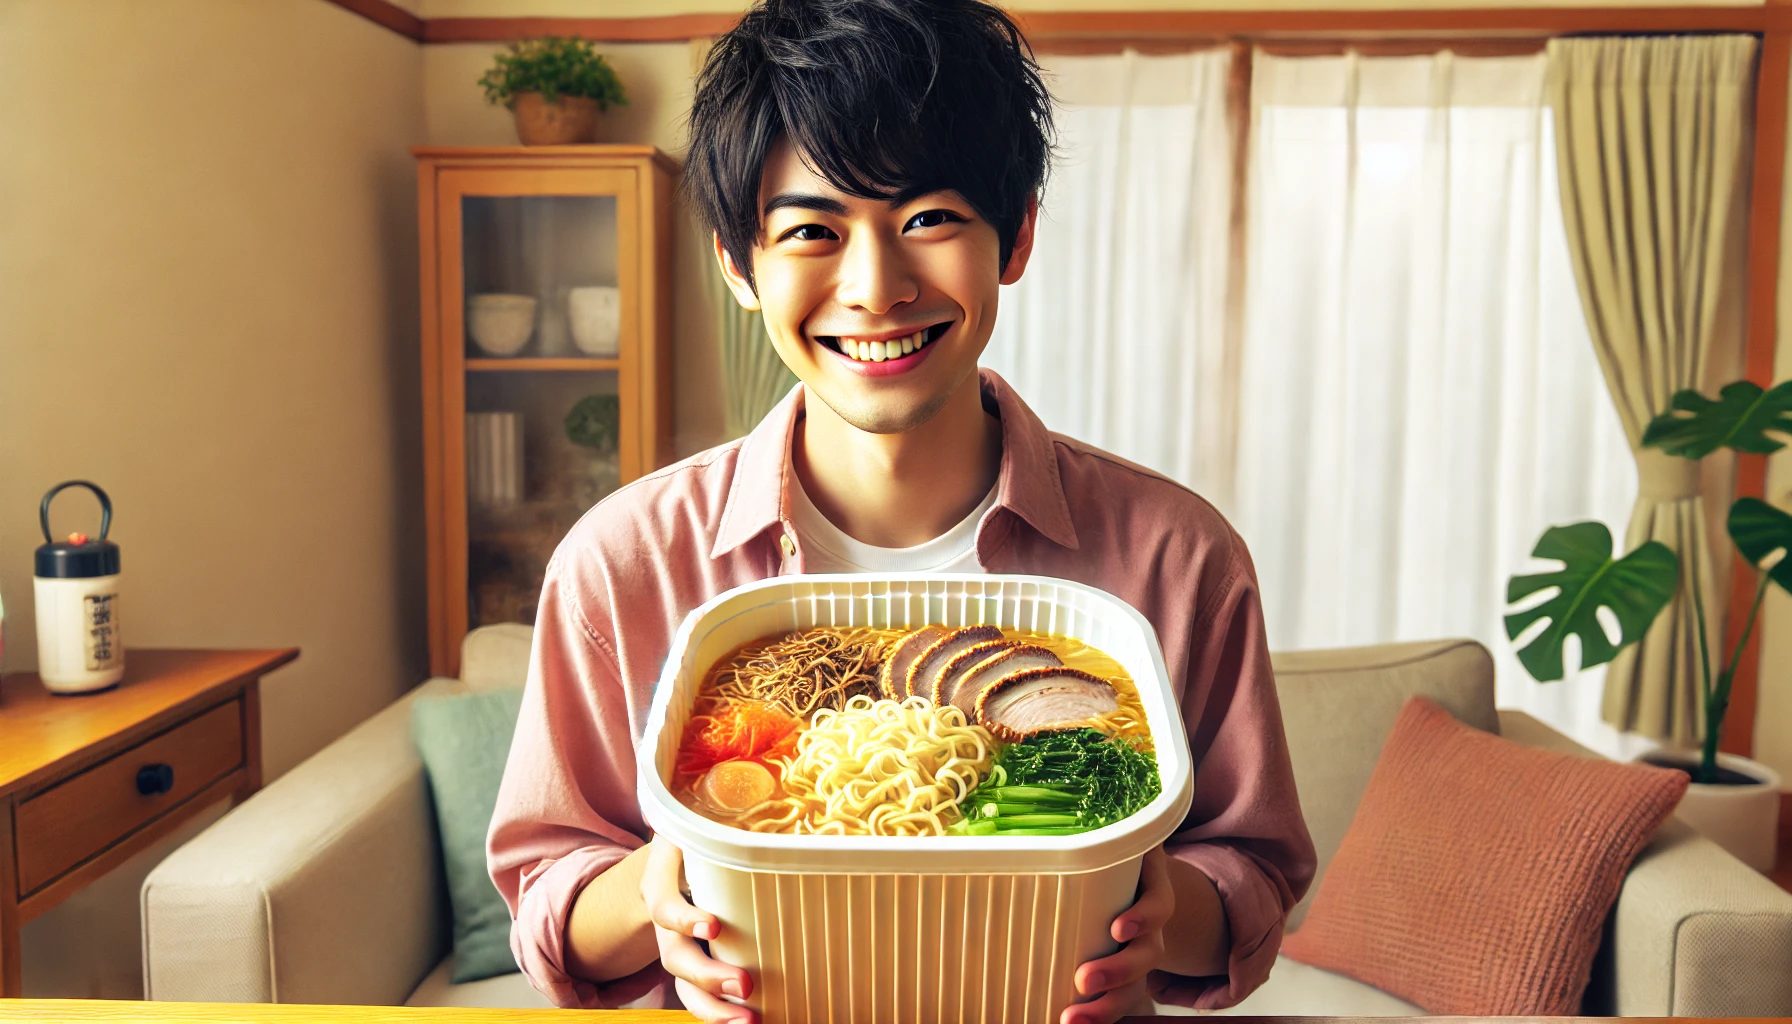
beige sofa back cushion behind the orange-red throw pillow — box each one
[1271,640,1500,931]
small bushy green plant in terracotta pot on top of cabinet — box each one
[478,36,629,145]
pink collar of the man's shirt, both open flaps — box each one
[710,369,1077,558]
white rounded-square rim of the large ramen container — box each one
[636,572,1193,875]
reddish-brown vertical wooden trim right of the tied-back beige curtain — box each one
[1720,26,1792,757]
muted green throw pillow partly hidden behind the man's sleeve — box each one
[410,689,523,985]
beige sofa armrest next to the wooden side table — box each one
[142,680,461,1004]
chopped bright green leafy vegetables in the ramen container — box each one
[950,728,1163,836]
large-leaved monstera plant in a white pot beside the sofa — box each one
[1505,380,1792,872]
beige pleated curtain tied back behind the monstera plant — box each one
[1546,36,1756,744]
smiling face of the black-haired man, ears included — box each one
[717,142,1034,434]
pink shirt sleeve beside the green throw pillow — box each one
[486,560,658,1008]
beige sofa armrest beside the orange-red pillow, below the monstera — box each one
[1500,712,1792,1017]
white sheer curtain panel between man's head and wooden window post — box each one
[984,50,1233,481]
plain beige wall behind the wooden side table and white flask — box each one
[0,0,426,995]
